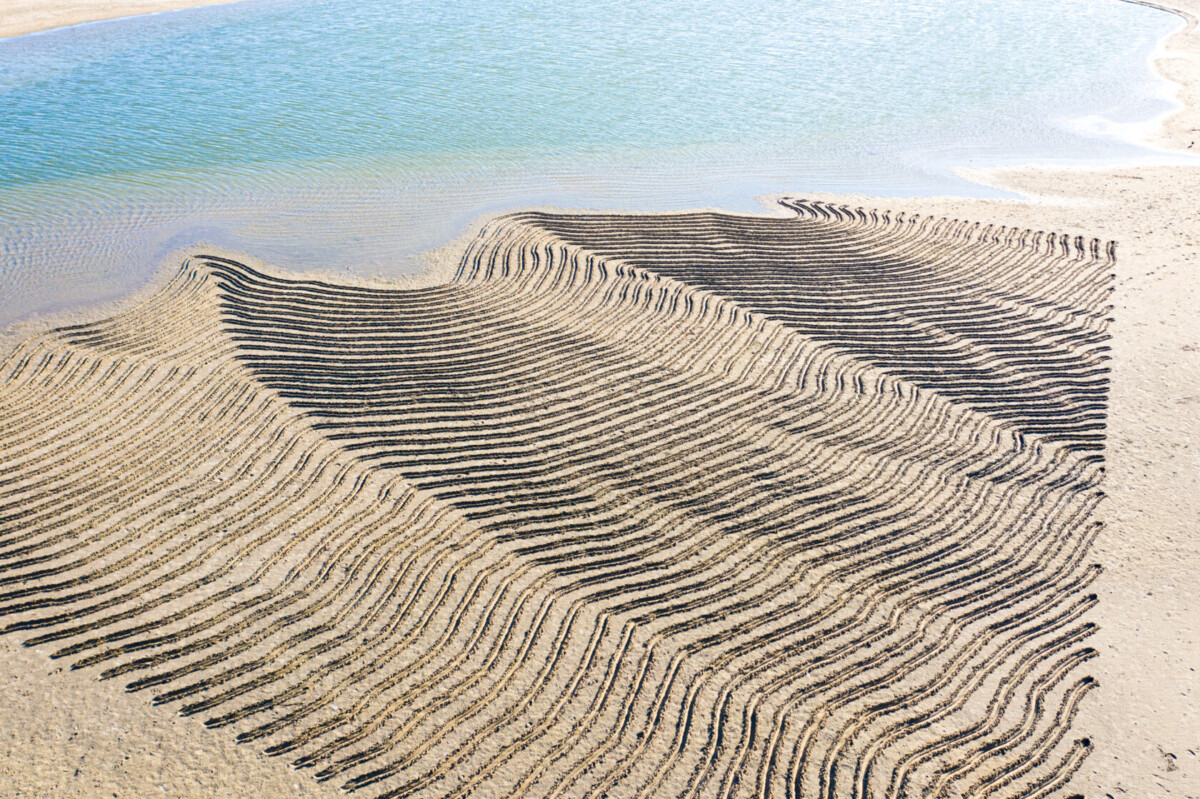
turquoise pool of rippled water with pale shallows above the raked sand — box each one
[0,0,1178,324]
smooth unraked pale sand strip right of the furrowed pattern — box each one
[787,161,1200,799]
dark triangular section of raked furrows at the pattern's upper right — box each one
[522,205,1110,450]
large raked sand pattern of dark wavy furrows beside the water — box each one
[0,200,1112,797]
